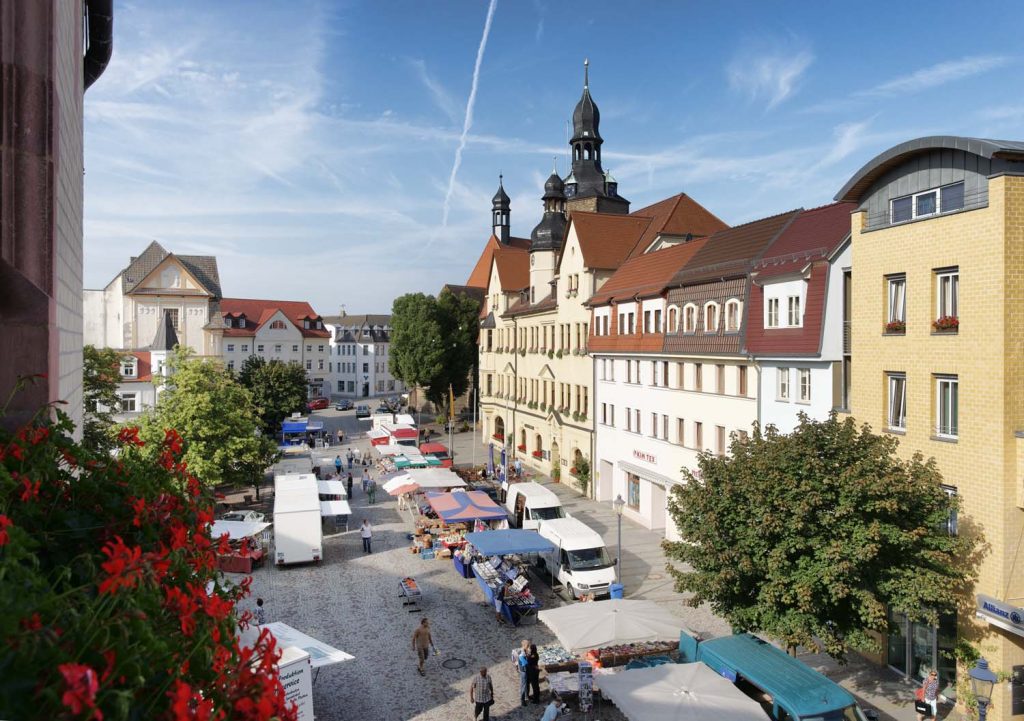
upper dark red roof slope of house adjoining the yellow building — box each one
[753,203,857,279]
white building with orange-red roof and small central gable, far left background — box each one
[220,298,331,397]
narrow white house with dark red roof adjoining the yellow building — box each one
[746,203,855,433]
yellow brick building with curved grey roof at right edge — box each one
[836,136,1024,720]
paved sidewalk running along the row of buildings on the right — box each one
[444,433,925,721]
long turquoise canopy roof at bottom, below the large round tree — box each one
[679,633,876,721]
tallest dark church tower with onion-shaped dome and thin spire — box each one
[565,60,630,215]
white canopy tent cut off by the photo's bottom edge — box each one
[583,663,766,721]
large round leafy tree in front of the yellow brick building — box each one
[665,414,975,661]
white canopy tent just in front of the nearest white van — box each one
[538,598,688,653]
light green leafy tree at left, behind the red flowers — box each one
[139,350,276,485]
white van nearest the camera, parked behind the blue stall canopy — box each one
[538,518,615,598]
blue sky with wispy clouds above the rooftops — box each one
[85,0,1024,314]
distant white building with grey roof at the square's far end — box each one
[324,311,407,398]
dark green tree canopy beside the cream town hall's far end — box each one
[388,291,479,407]
